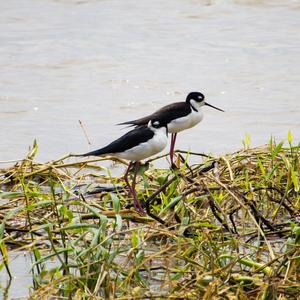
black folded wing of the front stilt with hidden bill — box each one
[82,126,154,156]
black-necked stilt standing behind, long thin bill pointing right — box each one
[118,92,224,165]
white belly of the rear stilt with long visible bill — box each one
[168,109,203,133]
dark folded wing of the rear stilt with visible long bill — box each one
[118,102,191,126]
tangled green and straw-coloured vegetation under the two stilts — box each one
[0,134,300,299]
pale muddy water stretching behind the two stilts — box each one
[0,0,300,298]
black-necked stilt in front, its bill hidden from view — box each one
[80,119,168,213]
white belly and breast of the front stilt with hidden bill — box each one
[115,127,168,161]
